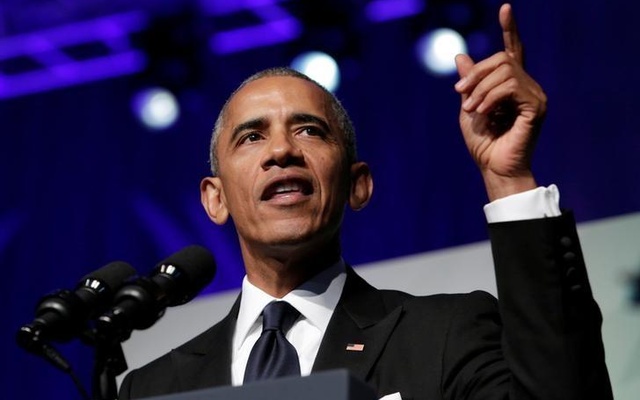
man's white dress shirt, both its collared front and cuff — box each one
[231,185,561,386]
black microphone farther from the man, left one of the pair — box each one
[16,261,136,354]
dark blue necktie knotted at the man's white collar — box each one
[244,301,300,383]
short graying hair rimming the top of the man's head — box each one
[209,67,358,176]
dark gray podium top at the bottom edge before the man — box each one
[139,369,377,400]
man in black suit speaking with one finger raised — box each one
[121,5,612,399]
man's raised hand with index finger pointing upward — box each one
[455,4,547,201]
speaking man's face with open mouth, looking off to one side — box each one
[212,77,350,252]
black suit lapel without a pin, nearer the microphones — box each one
[171,297,240,390]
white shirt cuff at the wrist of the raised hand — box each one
[484,185,561,224]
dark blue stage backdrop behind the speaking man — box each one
[0,0,640,400]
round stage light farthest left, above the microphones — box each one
[132,87,180,130]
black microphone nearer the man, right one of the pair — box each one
[97,245,216,340]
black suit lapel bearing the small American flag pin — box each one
[313,268,402,380]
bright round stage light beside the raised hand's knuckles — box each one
[416,28,467,75]
